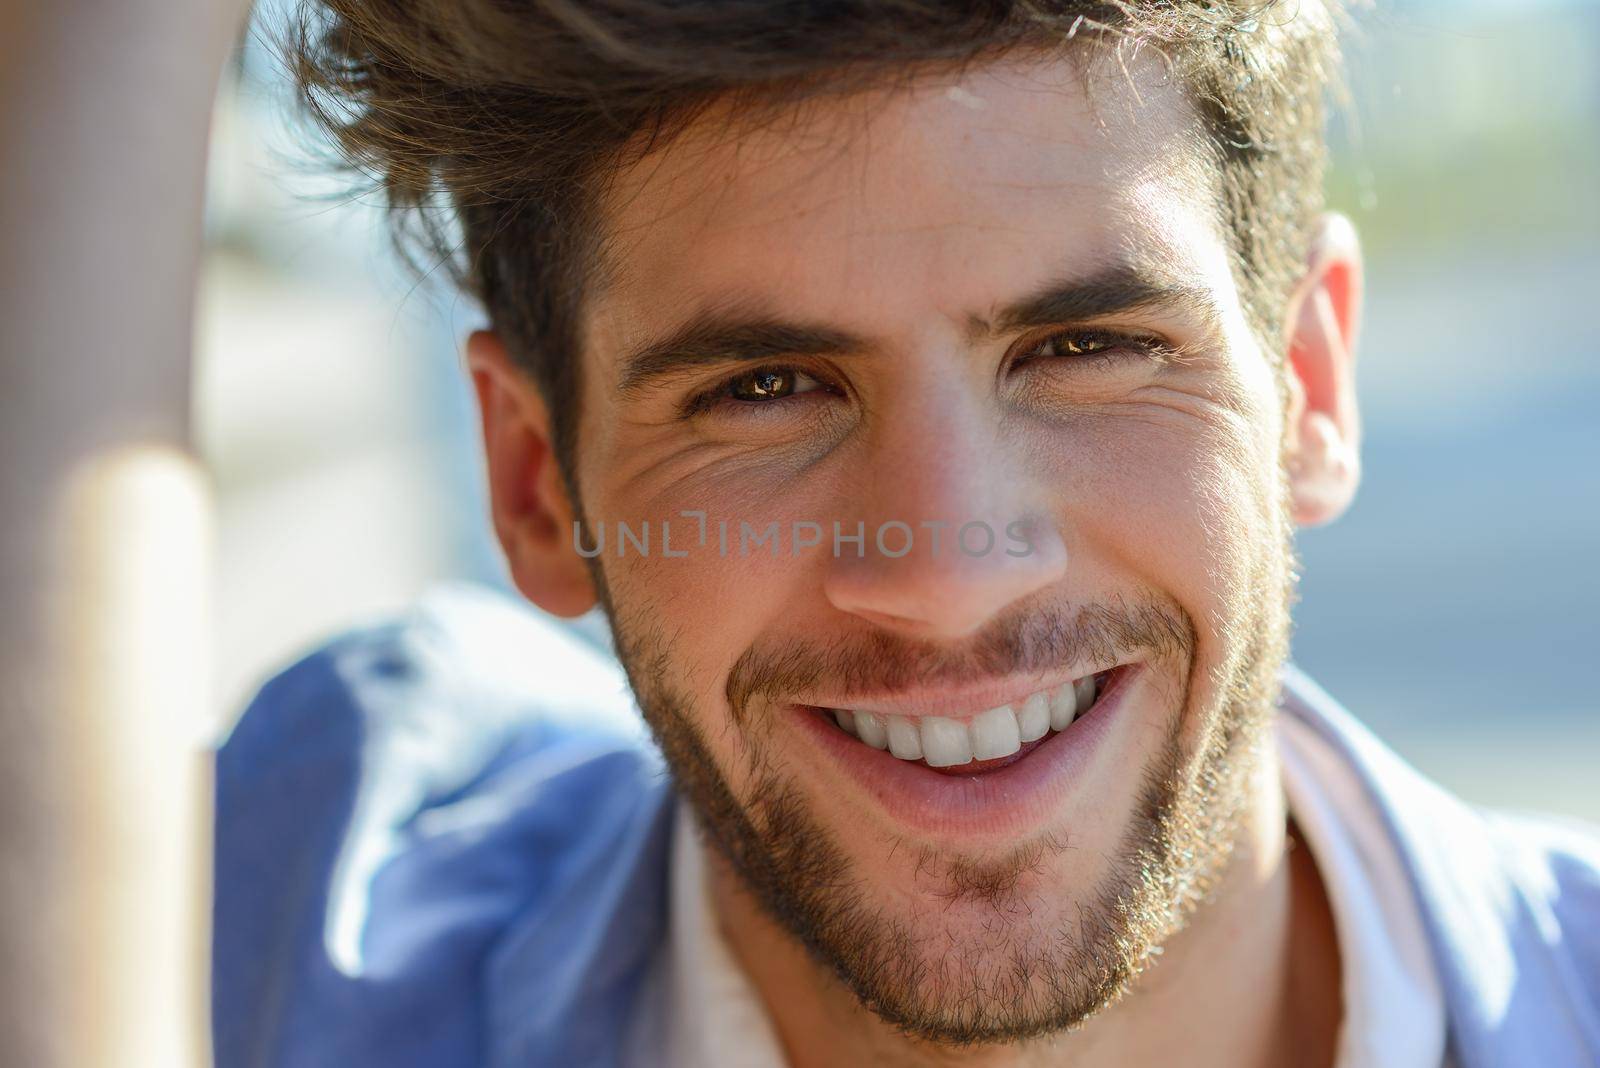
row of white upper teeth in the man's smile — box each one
[834,675,1094,767]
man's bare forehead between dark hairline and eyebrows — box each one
[584,53,1232,365]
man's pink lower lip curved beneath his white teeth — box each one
[790,665,1139,838]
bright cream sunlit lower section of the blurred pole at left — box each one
[56,444,213,1068]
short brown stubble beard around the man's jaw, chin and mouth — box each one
[594,511,1294,1047]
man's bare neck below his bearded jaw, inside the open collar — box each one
[702,745,1339,1068]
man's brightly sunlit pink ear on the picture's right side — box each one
[1285,214,1362,526]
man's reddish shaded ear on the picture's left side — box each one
[467,331,595,616]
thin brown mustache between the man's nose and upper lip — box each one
[725,595,1198,726]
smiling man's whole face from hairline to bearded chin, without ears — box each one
[576,49,1290,1039]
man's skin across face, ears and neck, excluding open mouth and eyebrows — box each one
[469,47,1360,1065]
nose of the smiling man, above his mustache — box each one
[824,383,1067,640]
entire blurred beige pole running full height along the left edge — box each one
[0,0,246,1068]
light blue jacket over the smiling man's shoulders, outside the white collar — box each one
[213,587,1600,1068]
